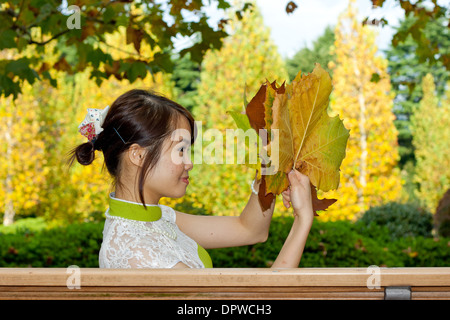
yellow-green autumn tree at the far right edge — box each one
[411,74,450,212]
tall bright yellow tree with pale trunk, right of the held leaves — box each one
[322,1,401,220]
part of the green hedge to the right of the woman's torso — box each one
[210,218,450,267]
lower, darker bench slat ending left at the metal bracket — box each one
[0,286,384,300]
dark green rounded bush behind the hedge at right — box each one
[356,202,433,241]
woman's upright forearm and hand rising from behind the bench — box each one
[272,170,314,268]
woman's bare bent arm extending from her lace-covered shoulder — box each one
[175,172,275,249]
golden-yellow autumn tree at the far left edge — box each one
[0,70,48,226]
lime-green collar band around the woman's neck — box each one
[109,192,162,221]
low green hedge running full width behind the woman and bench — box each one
[0,217,450,268]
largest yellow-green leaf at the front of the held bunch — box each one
[266,64,349,194]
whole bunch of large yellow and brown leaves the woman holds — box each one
[230,64,349,214]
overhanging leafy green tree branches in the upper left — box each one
[0,0,230,98]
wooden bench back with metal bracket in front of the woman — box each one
[0,267,450,300]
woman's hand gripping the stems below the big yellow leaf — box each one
[281,169,314,224]
